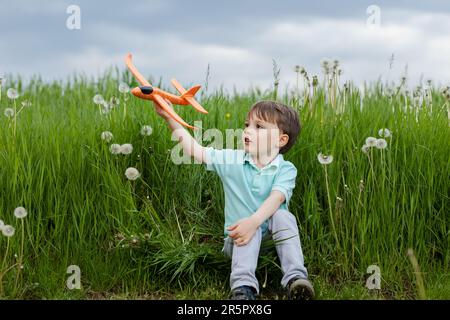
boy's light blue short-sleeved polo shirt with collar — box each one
[206,147,297,237]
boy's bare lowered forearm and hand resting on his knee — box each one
[227,190,285,246]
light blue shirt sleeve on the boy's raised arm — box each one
[205,147,242,177]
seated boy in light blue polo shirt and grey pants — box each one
[155,101,314,300]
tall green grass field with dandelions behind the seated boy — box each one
[0,63,450,299]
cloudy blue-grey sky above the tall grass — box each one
[0,0,450,91]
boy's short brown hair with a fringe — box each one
[247,101,301,153]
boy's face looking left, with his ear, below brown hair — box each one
[242,117,289,156]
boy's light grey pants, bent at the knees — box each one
[222,209,308,294]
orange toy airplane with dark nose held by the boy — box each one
[125,53,208,129]
